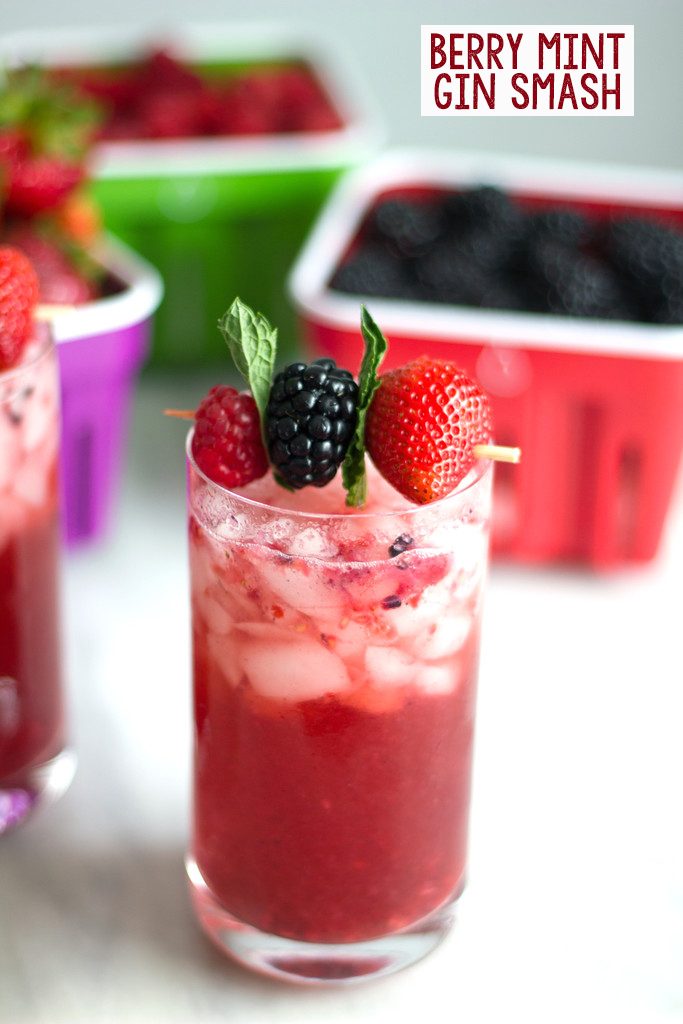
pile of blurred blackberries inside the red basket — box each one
[330,185,683,324]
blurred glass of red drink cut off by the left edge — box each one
[0,331,74,833]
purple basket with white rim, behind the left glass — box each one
[52,238,163,545]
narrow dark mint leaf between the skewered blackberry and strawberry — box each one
[342,306,388,508]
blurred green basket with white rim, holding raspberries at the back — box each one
[0,24,380,367]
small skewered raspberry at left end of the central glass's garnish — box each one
[193,385,268,487]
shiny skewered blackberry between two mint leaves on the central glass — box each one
[265,358,358,489]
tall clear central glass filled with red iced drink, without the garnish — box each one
[187,445,492,983]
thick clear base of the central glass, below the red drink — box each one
[185,857,456,986]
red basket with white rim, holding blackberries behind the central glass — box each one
[290,154,683,569]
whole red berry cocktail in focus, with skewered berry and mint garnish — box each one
[181,306,507,983]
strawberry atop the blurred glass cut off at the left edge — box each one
[0,246,38,371]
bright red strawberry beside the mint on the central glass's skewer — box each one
[366,356,492,505]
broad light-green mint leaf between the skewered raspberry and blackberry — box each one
[218,299,278,451]
